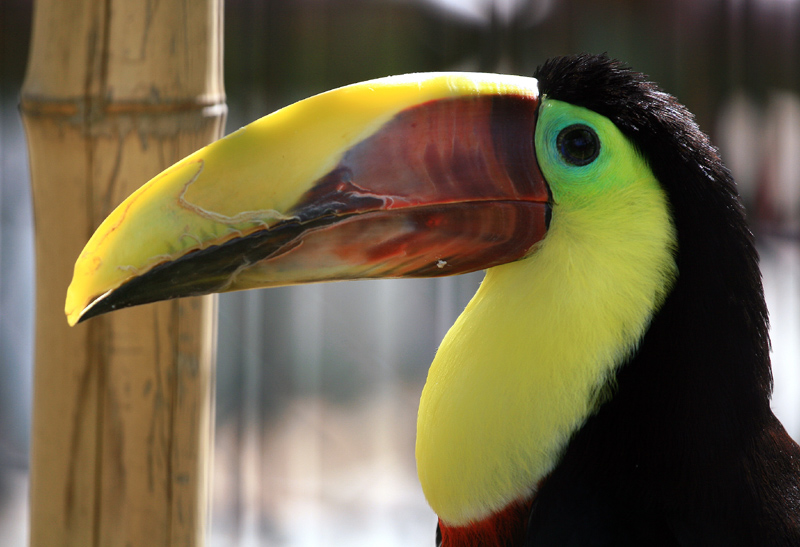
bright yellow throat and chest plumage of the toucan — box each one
[416,148,676,526]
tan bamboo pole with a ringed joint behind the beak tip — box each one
[21,0,226,547]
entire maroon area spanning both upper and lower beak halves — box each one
[281,96,548,277]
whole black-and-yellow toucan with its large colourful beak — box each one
[66,54,800,547]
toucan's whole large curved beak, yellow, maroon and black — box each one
[66,73,549,325]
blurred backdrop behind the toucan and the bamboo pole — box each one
[0,0,800,547]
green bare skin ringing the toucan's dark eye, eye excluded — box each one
[535,97,657,208]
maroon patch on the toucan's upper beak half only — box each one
[294,95,548,222]
